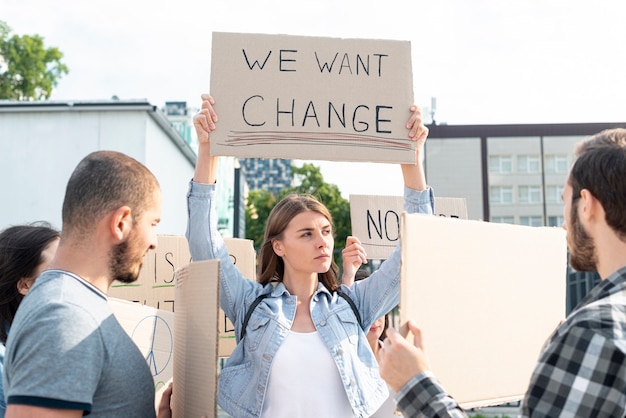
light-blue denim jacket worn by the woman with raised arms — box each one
[186,181,434,418]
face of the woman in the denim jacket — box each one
[272,211,335,276]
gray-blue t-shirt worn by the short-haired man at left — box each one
[4,270,156,417]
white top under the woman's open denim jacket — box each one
[261,331,354,418]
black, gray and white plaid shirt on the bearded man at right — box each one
[396,267,626,418]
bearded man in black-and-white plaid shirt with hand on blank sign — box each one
[380,129,626,417]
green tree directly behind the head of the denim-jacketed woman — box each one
[246,163,351,263]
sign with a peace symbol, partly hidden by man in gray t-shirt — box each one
[109,298,174,392]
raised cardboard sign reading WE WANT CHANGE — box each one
[211,32,415,163]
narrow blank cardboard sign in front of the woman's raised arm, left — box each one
[172,260,220,418]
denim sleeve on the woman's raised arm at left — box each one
[185,181,261,324]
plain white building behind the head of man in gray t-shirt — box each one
[0,100,196,235]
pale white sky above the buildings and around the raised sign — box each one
[0,0,626,197]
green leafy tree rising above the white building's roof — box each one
[0,21,69,100]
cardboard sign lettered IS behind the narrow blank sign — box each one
[108,235,256,357]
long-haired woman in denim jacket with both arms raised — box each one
[186,95,434,418]
